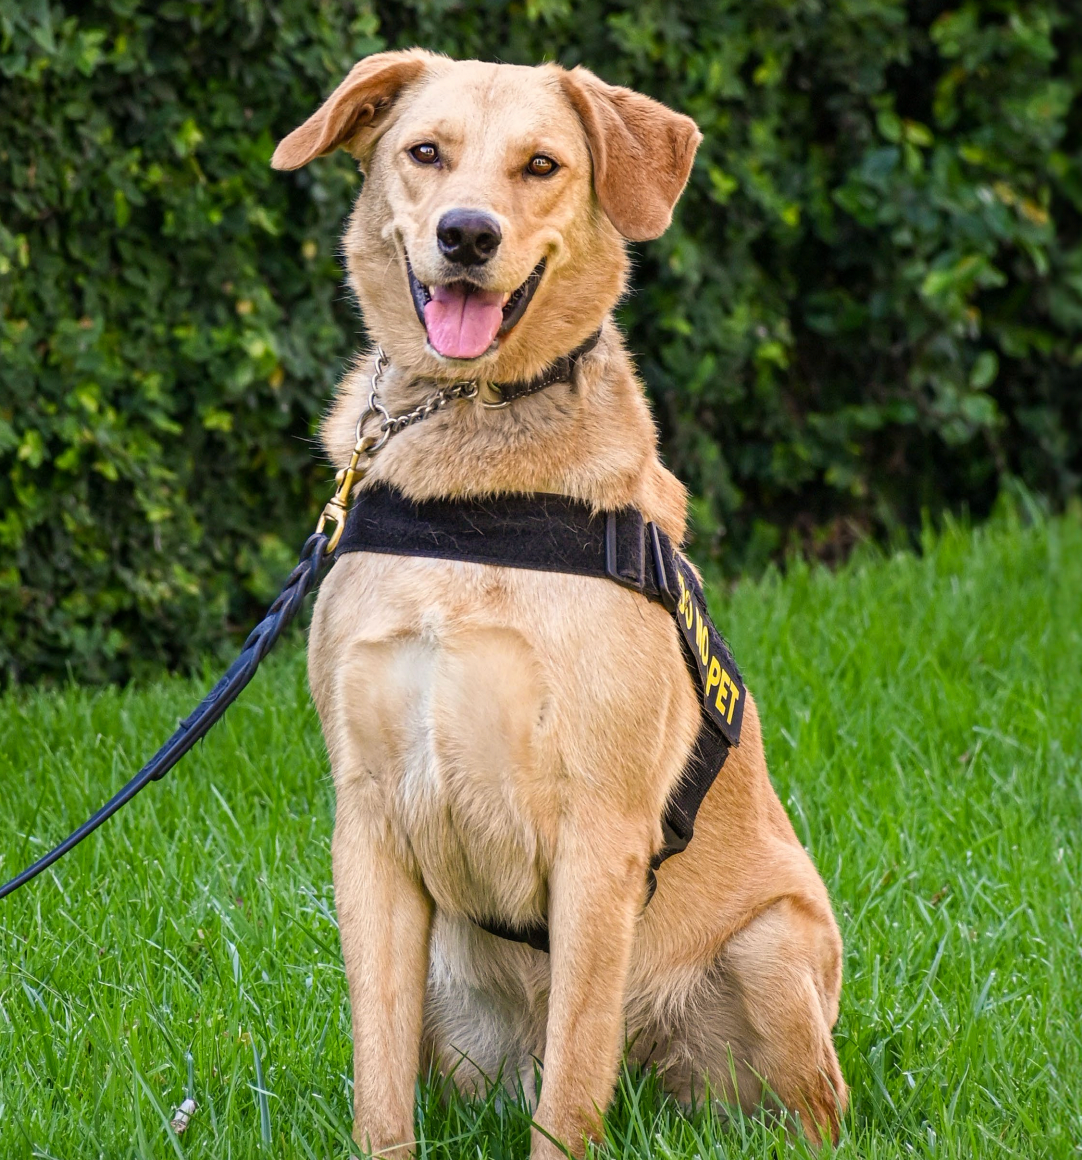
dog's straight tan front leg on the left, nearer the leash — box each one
[332,788,433,1158]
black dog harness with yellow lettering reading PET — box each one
[337,485,746,951]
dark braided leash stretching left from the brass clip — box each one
[0,531,331,899]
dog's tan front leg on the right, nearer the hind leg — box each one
[531,812,648,1160]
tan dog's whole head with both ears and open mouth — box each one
[273,50,700,379]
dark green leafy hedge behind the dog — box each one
[0,0,1082,680]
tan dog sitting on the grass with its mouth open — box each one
[273,50,847,1160]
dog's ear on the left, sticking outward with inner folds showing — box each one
[270,49,436,169]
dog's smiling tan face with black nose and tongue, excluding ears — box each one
[359,63,603,361]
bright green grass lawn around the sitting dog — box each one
[0,514,1082,1160]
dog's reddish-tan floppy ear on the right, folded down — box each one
[560,66,703,241]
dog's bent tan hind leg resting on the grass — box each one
[642,898,847,1144]
